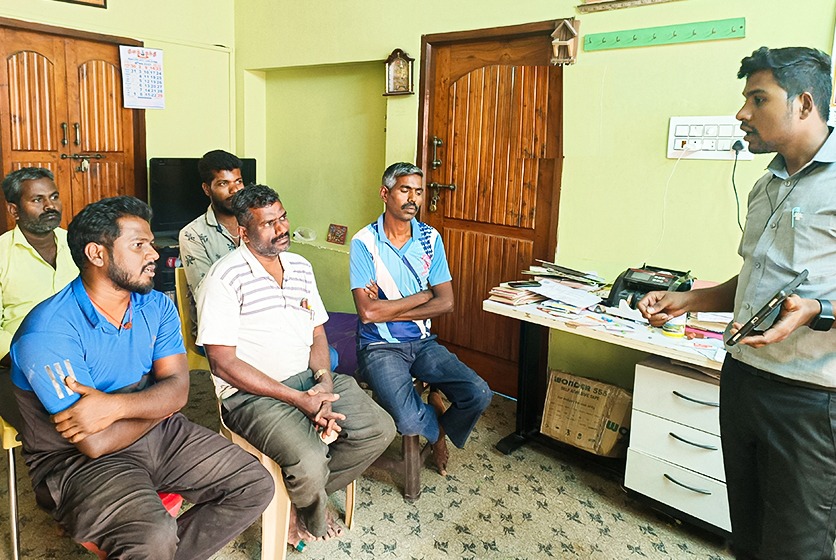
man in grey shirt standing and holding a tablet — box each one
[639,47,836,560]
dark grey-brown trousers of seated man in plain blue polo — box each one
[46,413,273,560]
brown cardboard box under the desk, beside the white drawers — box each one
[540,370,633,457]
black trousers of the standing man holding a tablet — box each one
[720,357,836,560]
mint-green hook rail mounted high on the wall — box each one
[583,18,746,51]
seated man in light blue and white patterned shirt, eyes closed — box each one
[350,163,493,475]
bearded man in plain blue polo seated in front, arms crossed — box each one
[11,196,273,560]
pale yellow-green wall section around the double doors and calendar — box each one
[0,0,235,164]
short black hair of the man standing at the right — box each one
[737,47,833,122]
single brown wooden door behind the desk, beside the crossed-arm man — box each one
[422,25,562,396]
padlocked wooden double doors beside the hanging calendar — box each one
[0,18,147,232]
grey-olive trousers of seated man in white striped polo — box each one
[223,369,395,537]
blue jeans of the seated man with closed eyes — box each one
[357,336,493,448]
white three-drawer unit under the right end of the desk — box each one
[624,356,731,531]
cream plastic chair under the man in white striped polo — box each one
[218,402,357,560]
